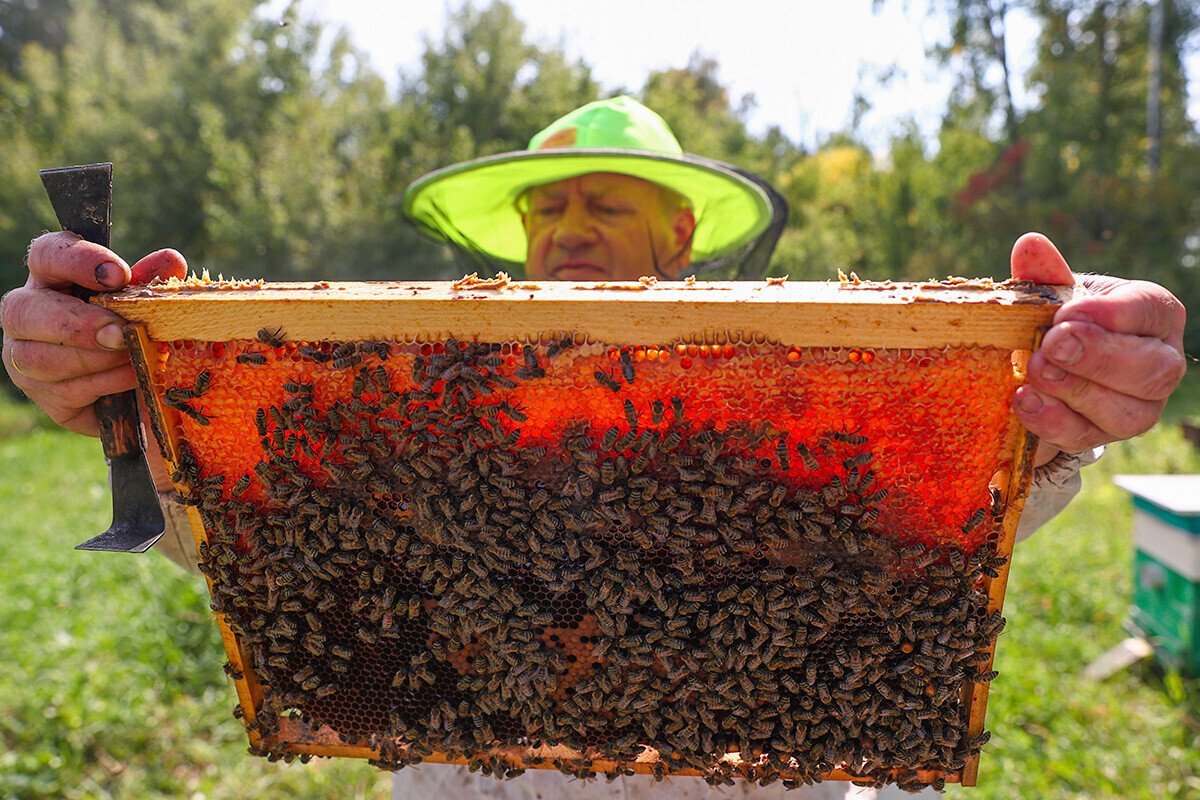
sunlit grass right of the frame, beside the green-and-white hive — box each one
[947,426,1200,800]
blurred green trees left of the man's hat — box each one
[0,0,463,291]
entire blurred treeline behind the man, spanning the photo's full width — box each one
[0,0,1200,353]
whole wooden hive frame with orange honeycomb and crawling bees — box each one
[102,279,1069,788]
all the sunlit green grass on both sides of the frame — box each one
[0,395,1200,800]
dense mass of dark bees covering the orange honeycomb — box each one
[168,331,1003,789]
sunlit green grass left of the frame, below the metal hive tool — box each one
[0,407,390,800]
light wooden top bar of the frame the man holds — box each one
[94,281,1074,349]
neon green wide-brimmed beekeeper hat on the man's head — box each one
[403,96,772,261]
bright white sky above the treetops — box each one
[266,0,1200,149]
